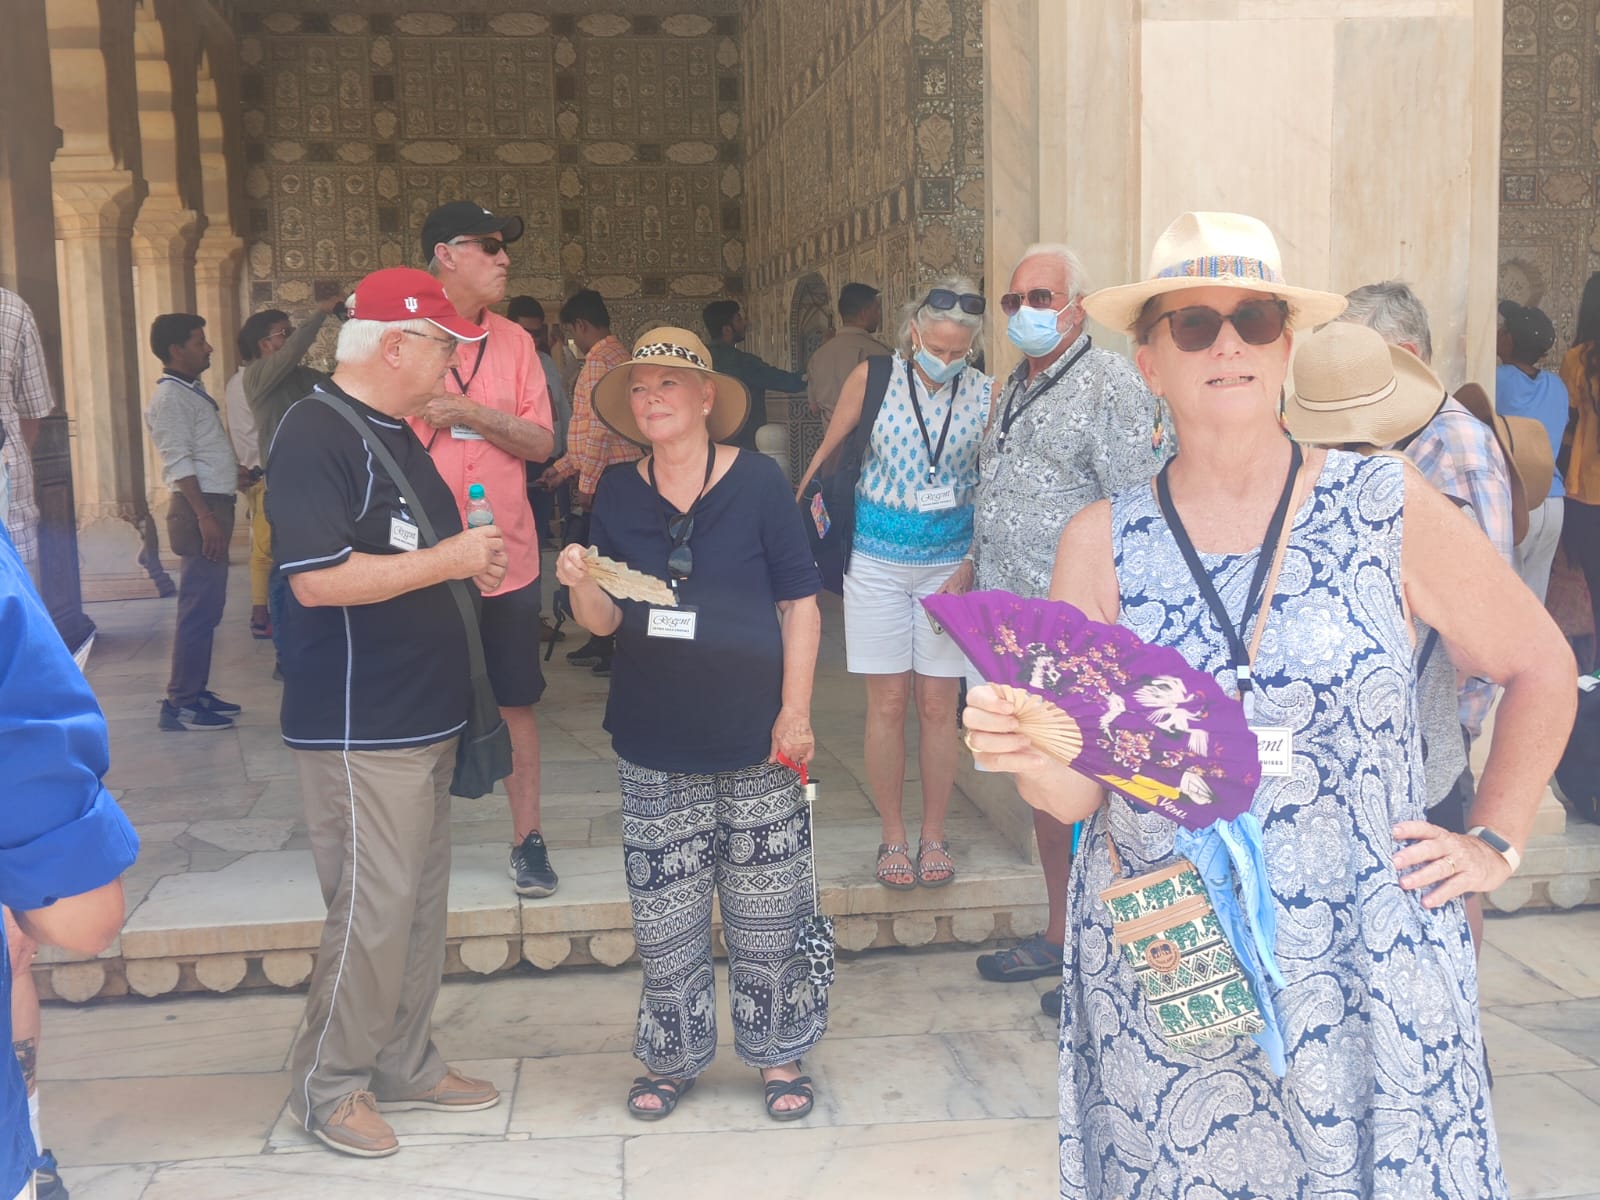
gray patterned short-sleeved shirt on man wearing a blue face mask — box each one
[973,334,1173,597]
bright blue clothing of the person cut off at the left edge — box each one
[0,528,139,1197]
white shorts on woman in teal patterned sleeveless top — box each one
[845,550,968,678]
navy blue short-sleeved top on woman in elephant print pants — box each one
[589,451,822,774]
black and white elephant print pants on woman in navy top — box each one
[618,758,827,1078]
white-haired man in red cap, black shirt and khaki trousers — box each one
[267,267,506,1158]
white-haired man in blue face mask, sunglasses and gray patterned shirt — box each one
[973,245,1173,1018]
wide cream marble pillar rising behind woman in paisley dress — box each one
[984,0,1501,384]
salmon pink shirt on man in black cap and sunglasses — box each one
[410,312,550,595]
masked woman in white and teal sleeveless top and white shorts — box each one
[800,277,994,891]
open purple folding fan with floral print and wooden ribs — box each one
[922,592,1261,829]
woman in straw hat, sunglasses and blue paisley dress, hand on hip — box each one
[966,213,1576,1200]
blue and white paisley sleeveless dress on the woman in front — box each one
[1061,453,1506,1200]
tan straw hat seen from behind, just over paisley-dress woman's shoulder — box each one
[1283,322,1445,446]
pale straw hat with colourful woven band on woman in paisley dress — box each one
[1083,213,1346,333]
